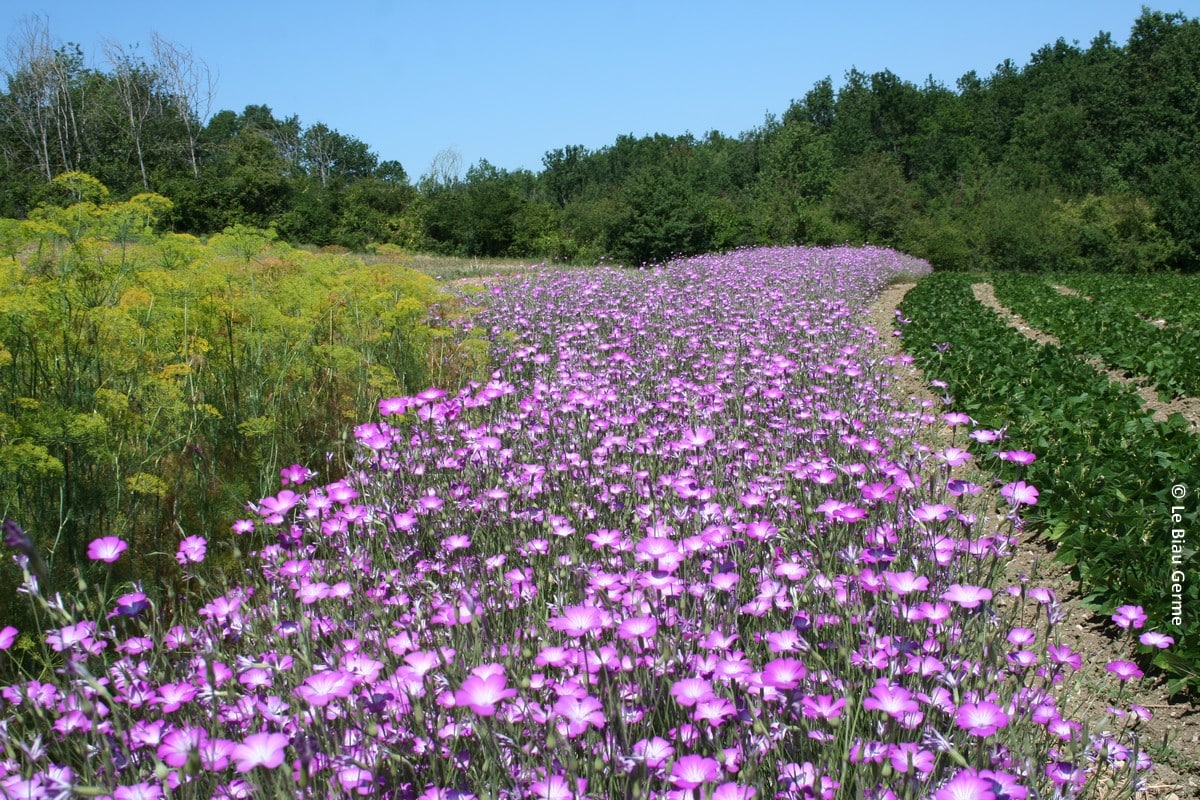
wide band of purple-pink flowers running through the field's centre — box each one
[0,248,1162,800]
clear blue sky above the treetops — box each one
[0,0,1200,180]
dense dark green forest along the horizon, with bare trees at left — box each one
[0,10,1200,271]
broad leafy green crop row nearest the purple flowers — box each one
[901,272,1200,690]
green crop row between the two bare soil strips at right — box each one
[994,273,1200,396]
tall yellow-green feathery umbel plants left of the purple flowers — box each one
[0,196,486,619]
